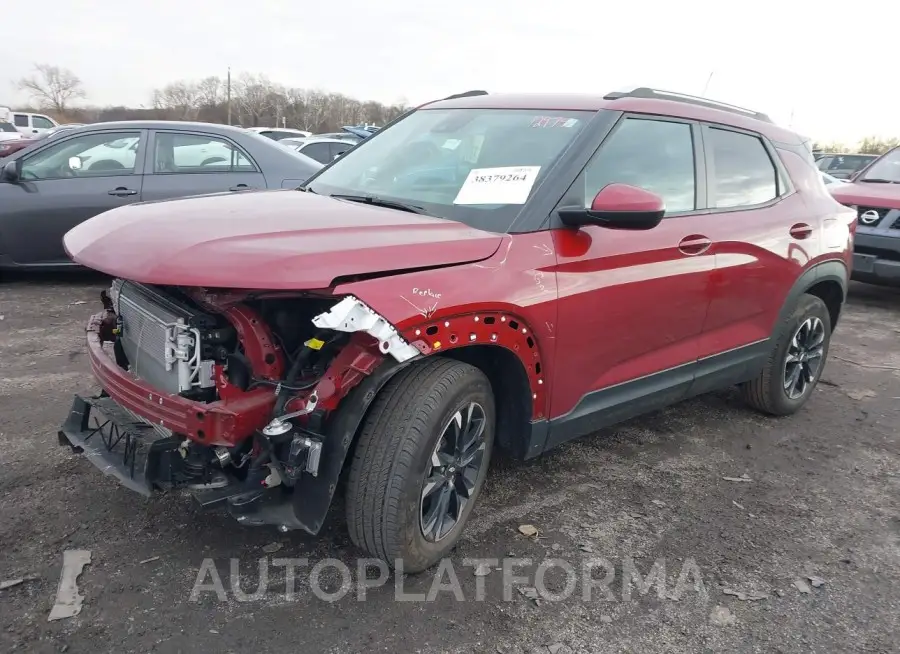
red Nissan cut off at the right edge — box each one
[829,148,900,286]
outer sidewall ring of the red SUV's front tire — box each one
[398,374,496,572]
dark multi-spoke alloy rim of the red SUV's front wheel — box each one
[419,402,487,543]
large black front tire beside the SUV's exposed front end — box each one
[346,357,496,573]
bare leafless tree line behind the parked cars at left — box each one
[9,64,408,133]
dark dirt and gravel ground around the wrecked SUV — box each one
[0,276,900,654]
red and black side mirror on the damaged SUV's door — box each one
[559,183,666,229]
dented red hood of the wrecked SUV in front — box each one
[63,190,503,290]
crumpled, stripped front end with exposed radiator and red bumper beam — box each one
[59,279,423,533]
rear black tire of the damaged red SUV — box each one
[741,294,831,416]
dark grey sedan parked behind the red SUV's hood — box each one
[0,121,322,268]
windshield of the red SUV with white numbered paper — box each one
[308,109,593,233]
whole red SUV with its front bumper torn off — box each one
[60,88,856,572]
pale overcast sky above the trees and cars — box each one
[0,0,900,141]
